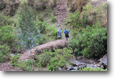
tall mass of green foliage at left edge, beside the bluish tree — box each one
[0,25,16,62]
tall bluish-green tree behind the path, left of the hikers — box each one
[17,5,42,50]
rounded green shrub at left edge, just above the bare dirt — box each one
[0,44,10,63]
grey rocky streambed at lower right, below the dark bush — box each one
[58,55,107,71]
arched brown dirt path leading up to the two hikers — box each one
[20,39,66,61]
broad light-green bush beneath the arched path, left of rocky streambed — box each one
[36,48,73,71]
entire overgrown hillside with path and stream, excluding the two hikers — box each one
[0,0,107,71]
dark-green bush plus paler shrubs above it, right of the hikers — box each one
[67,2,107,58]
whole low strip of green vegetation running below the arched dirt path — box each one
[11,48,74,71]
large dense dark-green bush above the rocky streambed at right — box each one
[69,25,107,58]
